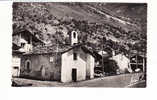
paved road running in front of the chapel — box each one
[13,74,145,87]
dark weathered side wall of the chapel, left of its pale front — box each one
[21,54,61,81]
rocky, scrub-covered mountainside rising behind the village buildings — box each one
[13,2,147,52]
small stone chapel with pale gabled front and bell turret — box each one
[20,31,95,82]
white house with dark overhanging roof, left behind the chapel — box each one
[12,30,43,77]
